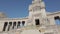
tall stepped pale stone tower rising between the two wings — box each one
[29,0,47,24]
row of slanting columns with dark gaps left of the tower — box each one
[3,21,25,31]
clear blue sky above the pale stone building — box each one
[0,0,60,18]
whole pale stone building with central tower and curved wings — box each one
[0,0,60,34]
